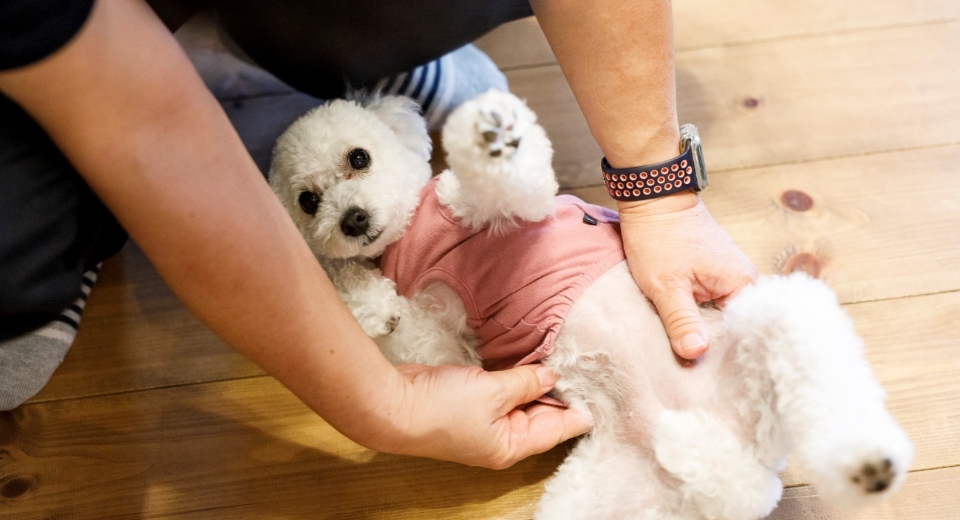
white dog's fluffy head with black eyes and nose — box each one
[270,96,431,258]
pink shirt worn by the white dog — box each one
[380,178,624,370]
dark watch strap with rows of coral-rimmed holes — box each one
[600,147,698,201]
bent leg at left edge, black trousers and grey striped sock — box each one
[0,92,126,409]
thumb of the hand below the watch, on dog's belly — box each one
[651,289,710,359]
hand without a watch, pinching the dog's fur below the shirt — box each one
[377,365,593,469]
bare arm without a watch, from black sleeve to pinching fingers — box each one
[0,0,590,467]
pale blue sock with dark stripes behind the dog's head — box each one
[374,44,508,132]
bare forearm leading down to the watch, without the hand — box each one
[531,0,697,211]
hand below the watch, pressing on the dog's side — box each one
[619,192,757,359]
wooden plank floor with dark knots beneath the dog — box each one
[0,0,960,520]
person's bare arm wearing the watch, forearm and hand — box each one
[531,0,756,359]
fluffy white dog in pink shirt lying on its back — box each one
[271,91,913,520]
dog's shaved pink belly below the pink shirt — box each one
[546,262,736,436]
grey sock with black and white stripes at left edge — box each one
[0,265,100,410]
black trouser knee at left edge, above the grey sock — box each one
[0,96,126,338]
